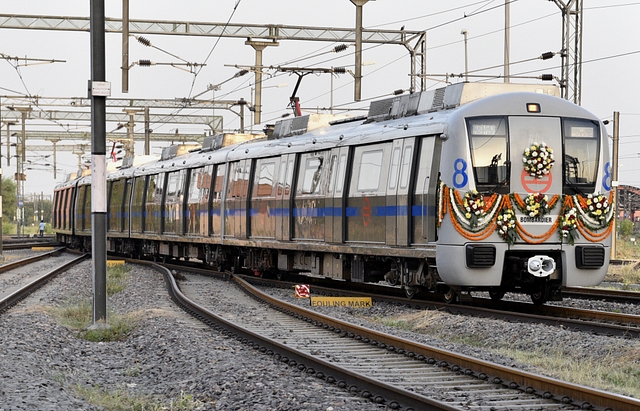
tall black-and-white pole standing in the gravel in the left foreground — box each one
[90,0,111,328]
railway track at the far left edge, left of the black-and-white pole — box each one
[0,247,86,312]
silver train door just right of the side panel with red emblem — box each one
[385,138,416,246]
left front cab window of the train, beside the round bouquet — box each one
[467,117,509,193]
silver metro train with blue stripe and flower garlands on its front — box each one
[53,83,614,305]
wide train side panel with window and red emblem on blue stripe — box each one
[345,142,393,244]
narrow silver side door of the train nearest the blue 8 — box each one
[411,136,442,244]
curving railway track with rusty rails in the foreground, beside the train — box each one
[145,264,640,411]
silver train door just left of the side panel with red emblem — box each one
[325,147,349,243]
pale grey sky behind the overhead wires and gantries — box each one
[0,0,640,200]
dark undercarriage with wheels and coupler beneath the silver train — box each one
[59,235,562,305]
